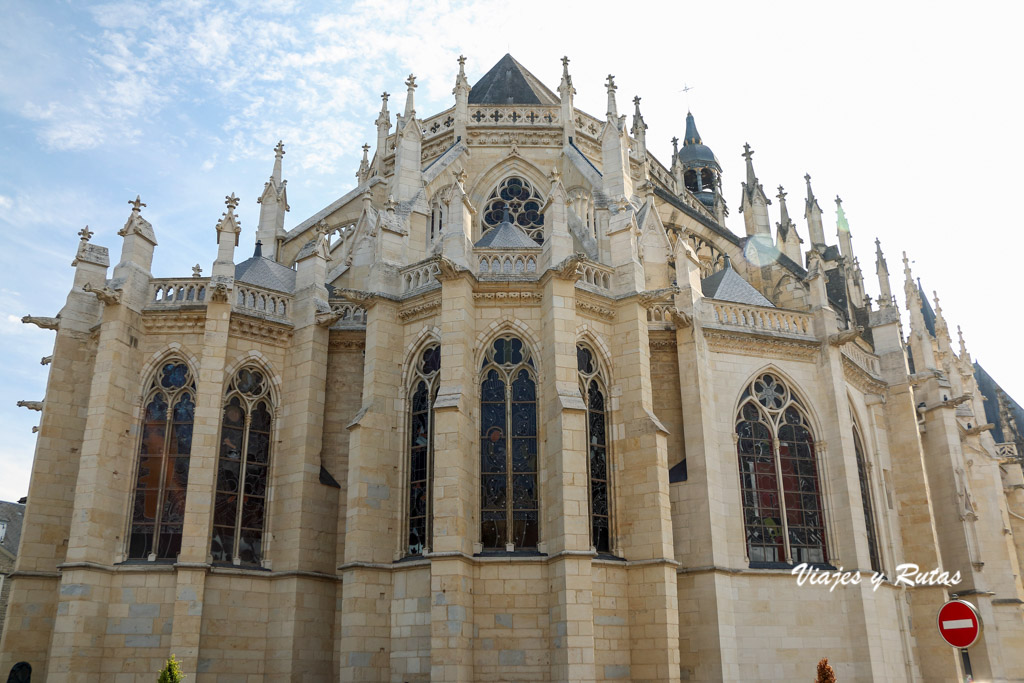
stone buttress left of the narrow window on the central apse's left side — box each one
[336,300,404,681]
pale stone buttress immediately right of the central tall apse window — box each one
[532,276,596,681]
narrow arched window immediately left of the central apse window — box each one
[406,346,441,555]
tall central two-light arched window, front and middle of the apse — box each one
[480,337,540,550]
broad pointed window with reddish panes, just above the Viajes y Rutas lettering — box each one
[736,373,828,563]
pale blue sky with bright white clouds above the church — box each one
[0,0,1024,500]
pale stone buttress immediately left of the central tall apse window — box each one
[430,278,480,683]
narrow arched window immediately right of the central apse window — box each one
[577,346,611,553]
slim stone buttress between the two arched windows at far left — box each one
[171,301,231,677]
